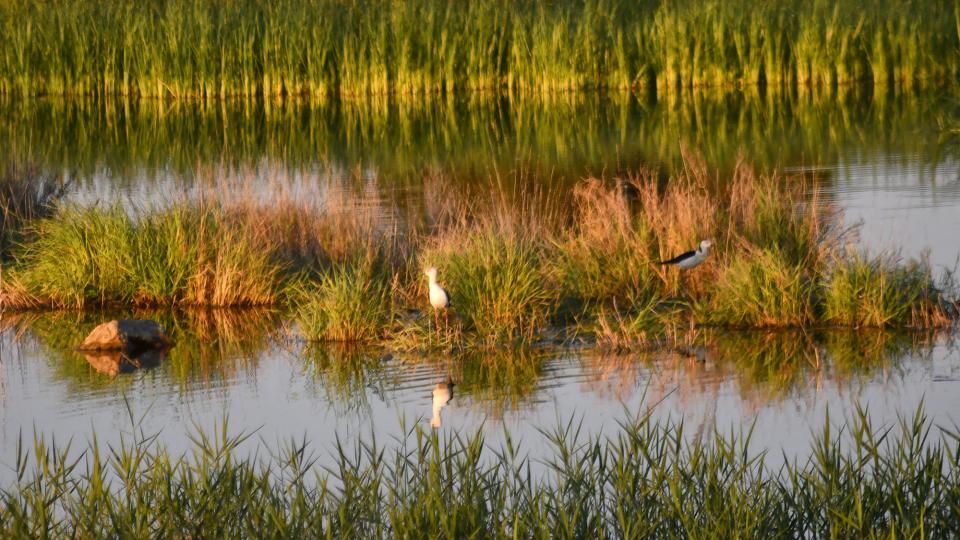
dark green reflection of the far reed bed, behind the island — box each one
[0,92,960,182]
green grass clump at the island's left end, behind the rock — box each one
[4,206,280,308]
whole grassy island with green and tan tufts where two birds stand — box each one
[0,160,960,348]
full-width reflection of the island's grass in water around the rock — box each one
[0,310,950,427]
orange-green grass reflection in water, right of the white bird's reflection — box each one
[580,329,943,414]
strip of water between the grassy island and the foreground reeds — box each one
[0,314,960,477]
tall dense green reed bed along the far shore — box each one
[0,0,960,99]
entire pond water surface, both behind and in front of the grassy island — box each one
[0,91,960,478]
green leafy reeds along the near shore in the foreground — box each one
[0,409,960,538]
